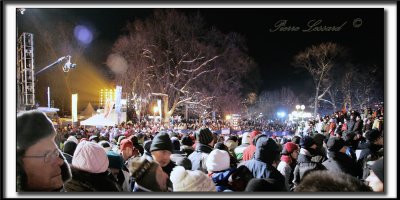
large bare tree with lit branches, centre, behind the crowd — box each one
[107,9,251,125]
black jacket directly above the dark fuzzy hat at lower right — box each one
[322,152,361,177]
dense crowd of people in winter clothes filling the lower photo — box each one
[17,109,384,192]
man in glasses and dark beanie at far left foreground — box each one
[16,111,71,192]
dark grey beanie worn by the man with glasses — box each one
[17,111,56,151]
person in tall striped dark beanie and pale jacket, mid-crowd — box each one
[188,127,213,173]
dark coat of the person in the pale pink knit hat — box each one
[65,167,120,192]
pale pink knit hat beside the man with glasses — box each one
[72,141,109,173]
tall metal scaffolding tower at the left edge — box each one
[17,33,35,110]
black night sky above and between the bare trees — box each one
[18,8,384,110]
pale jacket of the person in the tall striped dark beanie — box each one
[188,143,213,174]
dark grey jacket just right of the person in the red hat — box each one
[293,148,326,186]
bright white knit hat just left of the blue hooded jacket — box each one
[206,149,230,172]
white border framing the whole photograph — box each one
[2,1,397,198]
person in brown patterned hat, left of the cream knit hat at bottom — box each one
[128,156,172,192]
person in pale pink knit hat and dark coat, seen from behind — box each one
[65,141,120,192]
